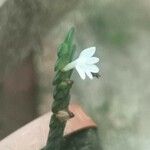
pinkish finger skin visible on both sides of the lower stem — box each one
[0,104,96,150]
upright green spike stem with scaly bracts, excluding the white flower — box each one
[45,28,75,150]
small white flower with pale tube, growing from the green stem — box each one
[63,47,99,80]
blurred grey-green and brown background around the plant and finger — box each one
[0,0,150,150]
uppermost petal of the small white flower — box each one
[79,47,96,57]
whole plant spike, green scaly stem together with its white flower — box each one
[44,28,99,150]
